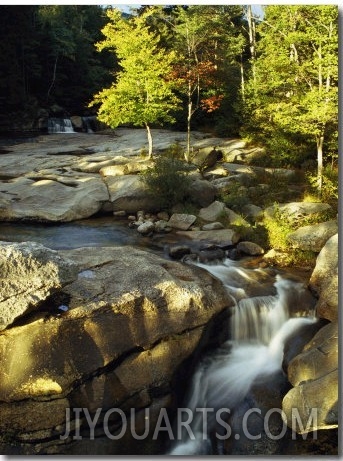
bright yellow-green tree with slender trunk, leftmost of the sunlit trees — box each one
[91,8,178,157]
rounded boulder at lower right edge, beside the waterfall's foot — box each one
[282,322,338,434]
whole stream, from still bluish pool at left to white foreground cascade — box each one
[0,217,316,455]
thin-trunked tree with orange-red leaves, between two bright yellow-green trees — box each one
[148,5,244,162]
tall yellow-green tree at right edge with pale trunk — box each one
[245,5,338,190]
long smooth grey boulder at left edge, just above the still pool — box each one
[0,174,108,222]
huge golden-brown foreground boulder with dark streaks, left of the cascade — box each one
[0,247,232,455]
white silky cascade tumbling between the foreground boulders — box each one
[168,260,316,455]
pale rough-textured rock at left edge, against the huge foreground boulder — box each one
[0,242,77,330]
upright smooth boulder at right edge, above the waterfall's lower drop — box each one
[310,234,338,321]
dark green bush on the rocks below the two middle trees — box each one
[141,156,191,210]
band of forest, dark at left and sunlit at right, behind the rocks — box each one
[0,5,338,180]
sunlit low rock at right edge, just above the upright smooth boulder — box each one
[287,220,338,253]
